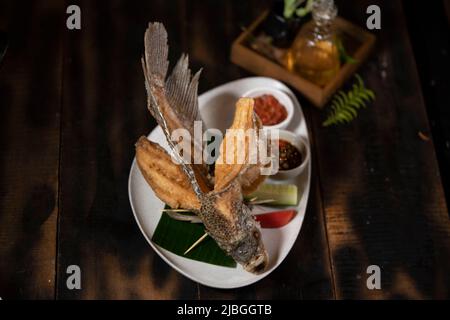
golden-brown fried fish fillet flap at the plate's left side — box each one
[136,137,200,210]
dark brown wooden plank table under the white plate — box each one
[0,0,450,299]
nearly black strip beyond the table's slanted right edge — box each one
[403,0,450,221]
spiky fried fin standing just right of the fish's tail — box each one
[166,54,201,131]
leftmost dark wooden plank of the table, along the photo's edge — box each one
[0,1,64,299]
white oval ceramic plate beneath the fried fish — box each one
[128,77,311,289]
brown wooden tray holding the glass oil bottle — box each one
[231,11,375,108]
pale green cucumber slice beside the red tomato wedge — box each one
[246,183,298,206]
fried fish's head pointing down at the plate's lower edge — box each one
[200,182,269,274]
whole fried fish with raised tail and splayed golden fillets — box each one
[136,23,268,273]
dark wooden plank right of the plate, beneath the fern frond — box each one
[312,1,450,298]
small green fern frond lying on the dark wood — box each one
[322,74,375,127]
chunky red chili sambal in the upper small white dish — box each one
[254,94,287,126]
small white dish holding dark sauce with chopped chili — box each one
[271,130,311,180]
